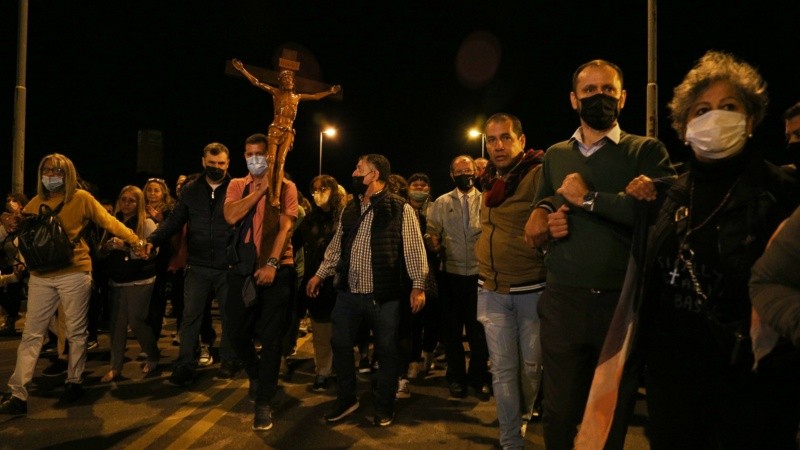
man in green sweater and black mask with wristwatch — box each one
[525,60,674,449]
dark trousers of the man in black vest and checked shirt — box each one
[331,291,400,416]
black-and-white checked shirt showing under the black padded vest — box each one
[317,197,428,294]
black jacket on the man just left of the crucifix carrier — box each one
[147,175,232,269]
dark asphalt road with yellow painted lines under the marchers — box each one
[0,304,649,450]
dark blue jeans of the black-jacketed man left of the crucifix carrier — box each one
[175,266,233,369]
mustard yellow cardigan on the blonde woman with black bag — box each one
[23,189,139,277]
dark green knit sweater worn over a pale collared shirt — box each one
[534,132,675,289]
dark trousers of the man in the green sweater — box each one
[538,284,635,450]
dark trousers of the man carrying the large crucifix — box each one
[225,266,296,405]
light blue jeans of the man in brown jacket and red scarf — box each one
[478,288,542,448]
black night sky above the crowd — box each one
[0,0,800,198]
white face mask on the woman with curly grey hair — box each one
[686,109,747,159]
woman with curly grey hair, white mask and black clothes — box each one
[618,51,800,450]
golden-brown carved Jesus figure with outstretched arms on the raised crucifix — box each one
[231,58,342,207]
